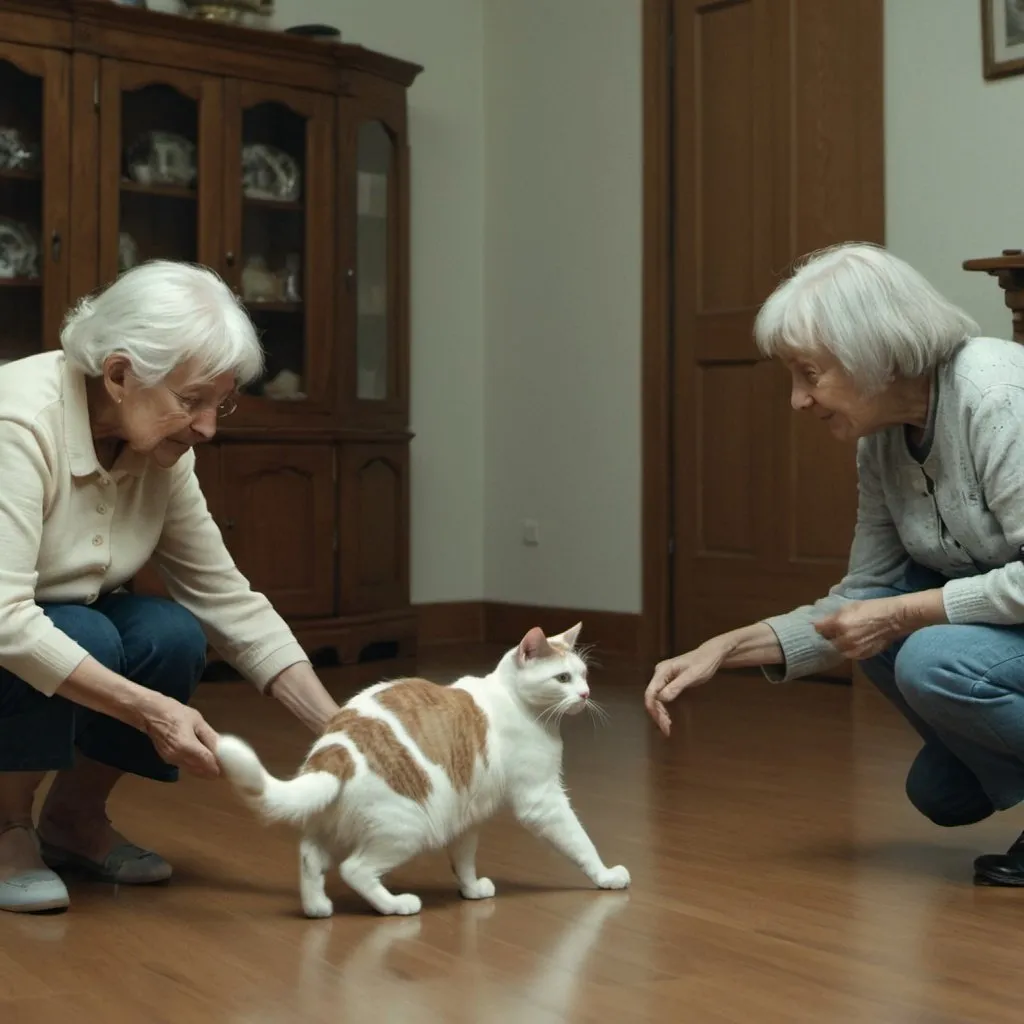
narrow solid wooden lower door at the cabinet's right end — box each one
[338,442,409,614]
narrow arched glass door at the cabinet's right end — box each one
[336,83,409,428]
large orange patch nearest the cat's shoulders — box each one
[377,679,487,791]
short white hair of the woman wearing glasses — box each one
[60,260,263,387]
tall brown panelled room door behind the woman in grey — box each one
[673,0,884,674]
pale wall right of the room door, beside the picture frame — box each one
[885,0,1024,337]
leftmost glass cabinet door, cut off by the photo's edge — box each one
[0,42,71,362]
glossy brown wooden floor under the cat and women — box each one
[0,657,1024,1024]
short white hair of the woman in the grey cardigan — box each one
[754,243,980,394]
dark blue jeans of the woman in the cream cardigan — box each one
[0,593,207,782]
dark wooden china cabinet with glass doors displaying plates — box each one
[0,0,422,672]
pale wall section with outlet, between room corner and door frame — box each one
[483,0,642,611]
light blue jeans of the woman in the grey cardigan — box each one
[853,563,1024,826]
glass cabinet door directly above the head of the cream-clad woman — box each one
[99,60,223,284]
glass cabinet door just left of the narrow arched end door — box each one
[224,82,334,415]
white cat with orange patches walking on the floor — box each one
[217,624,630,918]
